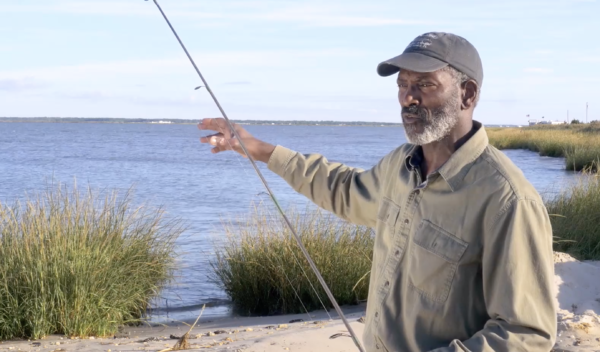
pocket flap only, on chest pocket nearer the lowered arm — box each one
[413,220,468,263]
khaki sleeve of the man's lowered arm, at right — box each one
[433,199,557,352]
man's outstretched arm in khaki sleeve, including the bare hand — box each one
[198,118,387,227]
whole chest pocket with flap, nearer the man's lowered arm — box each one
[408,220,468,303]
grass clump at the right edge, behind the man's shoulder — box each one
[546,166,600,260]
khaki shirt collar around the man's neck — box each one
[405,120,489,191]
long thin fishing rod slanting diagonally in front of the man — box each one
[145,0,365,352]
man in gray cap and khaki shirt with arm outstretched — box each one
[199,33,556,352]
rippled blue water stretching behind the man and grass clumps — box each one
[0,123,576,320]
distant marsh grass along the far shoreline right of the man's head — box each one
[488,125,600,171]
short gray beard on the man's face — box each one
[404,89,461,145]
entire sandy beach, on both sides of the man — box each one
[0,253,600,352]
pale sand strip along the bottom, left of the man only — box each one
[0,306,364,352]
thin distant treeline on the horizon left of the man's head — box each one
[0,117,402,126]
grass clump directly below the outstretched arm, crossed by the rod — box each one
[211,208,374,315]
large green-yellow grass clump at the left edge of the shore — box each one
[0,186,182,339]
